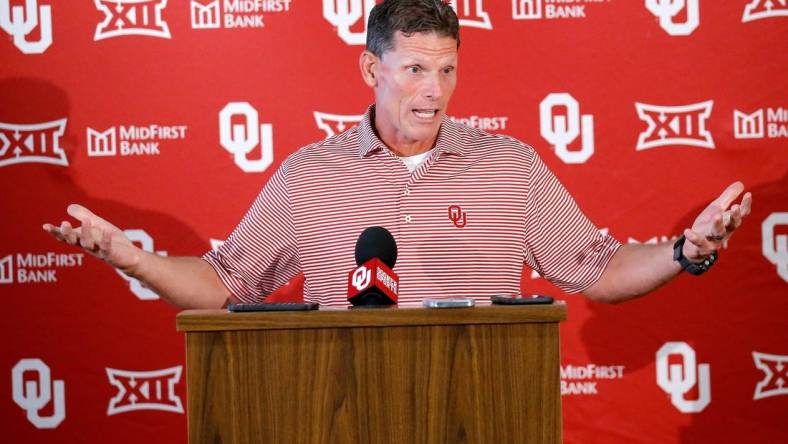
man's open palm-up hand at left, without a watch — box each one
[43,204,144,275]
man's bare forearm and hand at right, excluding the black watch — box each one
[584,182,752,303]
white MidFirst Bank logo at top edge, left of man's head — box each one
[191,0,292,29]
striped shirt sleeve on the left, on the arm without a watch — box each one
[203,165,301,303]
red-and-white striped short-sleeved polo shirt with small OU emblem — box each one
[203,106,620,306]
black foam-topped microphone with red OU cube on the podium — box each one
[347,227,399,306]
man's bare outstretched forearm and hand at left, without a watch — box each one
[43,204,237,308]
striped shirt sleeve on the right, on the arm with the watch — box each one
[524,151,621,293]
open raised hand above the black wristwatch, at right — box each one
[684,182,752,260]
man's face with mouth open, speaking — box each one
[373,32,457,155]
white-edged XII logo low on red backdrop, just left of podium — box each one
[105,365,183,416]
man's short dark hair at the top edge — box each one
[367,0,460,57]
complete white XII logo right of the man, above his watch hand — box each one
[635,100,714,151]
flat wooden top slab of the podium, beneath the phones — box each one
[176,301,566,332]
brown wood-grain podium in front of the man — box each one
[177,303,566,444]
